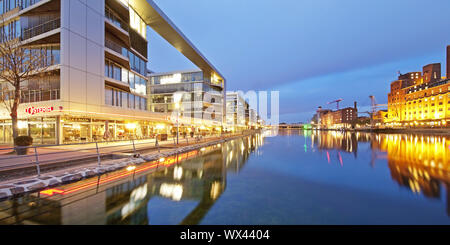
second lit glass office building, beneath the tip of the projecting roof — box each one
[149,70,225,131]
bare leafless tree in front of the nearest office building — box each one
[0,20,47,145]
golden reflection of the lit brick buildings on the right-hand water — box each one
[310,131,450,216]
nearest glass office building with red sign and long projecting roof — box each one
[0,0,225,144]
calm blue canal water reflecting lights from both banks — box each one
[0,130,450,225]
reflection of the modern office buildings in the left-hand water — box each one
[0,135,264,225]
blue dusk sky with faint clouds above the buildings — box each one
[148,0,450,122]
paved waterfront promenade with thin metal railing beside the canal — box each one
[0,131,252,177]
